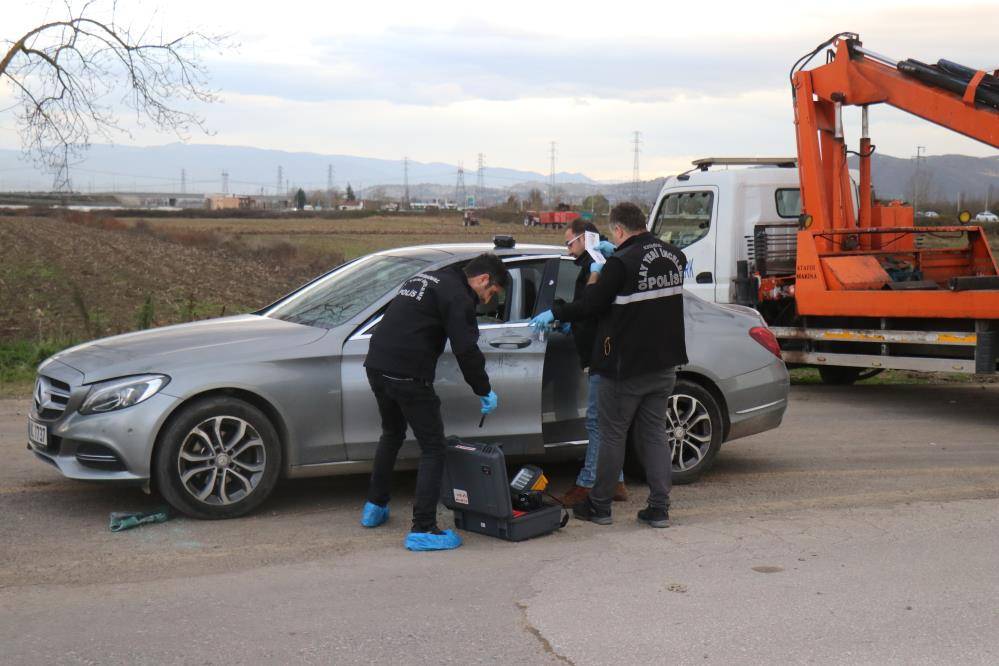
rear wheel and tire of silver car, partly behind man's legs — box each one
[624,379,725,485]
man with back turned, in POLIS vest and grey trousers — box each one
[552,203,687,527]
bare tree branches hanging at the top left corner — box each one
[0,0,228,178]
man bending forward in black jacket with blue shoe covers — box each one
[361,254,509,550]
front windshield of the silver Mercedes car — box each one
[261,255,430,328]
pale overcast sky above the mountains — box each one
[0,0,999,180]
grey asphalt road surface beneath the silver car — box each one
[0,385,999,664]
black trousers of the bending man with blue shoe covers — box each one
[367,368,444,531]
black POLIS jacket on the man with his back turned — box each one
[552,232,687,379]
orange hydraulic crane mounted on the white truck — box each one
[792,33,999,320]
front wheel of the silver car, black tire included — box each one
[153,396,282,520]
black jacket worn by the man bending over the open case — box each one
[364,268,491,395]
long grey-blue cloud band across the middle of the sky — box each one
[214,28,801,105]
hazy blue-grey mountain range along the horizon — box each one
[0,143,999,203]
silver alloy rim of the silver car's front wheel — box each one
[177,416,267,505]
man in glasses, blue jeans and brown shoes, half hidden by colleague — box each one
[531,218,628,506]
